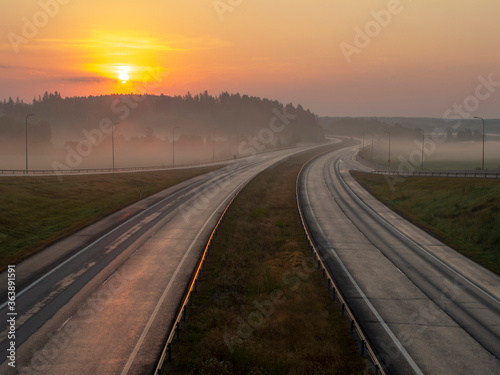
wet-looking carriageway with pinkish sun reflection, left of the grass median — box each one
[0,148,316,375]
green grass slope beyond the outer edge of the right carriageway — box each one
[351,171,500,274]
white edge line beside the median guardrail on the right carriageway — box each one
[304,157,424,375]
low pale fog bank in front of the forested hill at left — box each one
[0,129,287,169]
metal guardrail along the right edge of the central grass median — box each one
[295,150,388,375]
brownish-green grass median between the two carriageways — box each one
[164,145,368,375]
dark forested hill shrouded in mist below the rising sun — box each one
[0,91,324,169]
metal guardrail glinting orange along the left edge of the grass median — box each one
[154,187,243,375]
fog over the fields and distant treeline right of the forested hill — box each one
[322,118,500,171]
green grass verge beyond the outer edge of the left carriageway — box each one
[0,167,221,270]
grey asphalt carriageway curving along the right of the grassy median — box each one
[299,148,500,375]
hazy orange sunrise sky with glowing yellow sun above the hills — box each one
[0,0,500,118]
